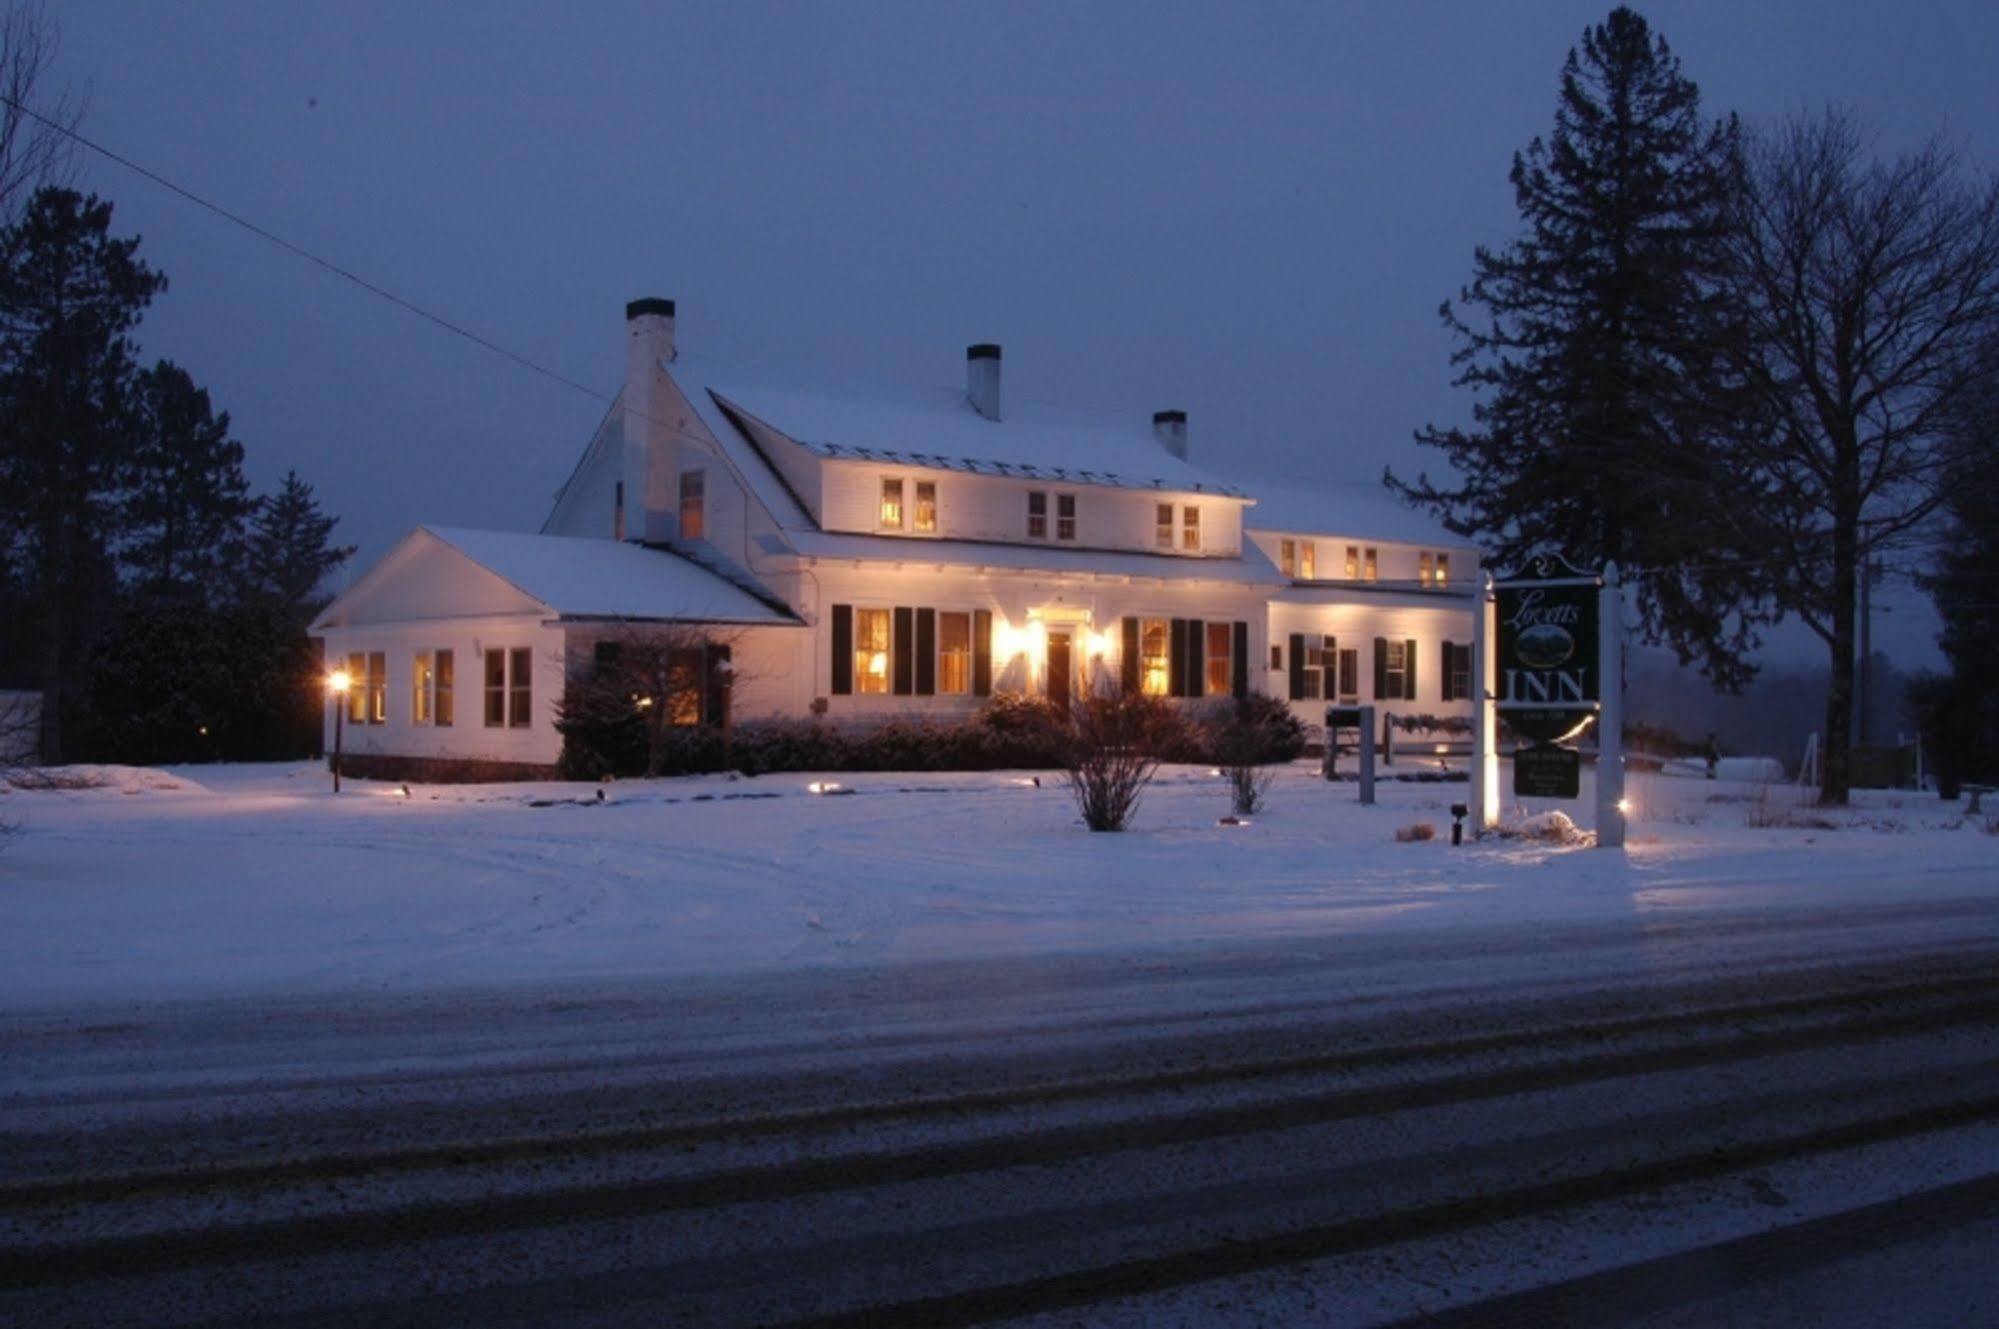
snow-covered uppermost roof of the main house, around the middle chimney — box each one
[666,356,1245,498]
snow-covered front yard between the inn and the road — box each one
[0,763,1999,1013]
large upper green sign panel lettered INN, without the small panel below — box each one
[1493,556,1603,747]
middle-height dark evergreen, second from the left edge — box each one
[120,360,254,604]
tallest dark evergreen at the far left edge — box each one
[0,188,166,761]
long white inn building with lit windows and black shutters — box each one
[314,300,1477,777]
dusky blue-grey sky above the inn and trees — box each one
[50,0,1999,664]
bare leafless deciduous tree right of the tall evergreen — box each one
[1735,110,1999,803]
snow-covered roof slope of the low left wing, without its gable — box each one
[418,526,798,624]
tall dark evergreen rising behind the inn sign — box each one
[1387,8,1767,687]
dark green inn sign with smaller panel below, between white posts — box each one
[1493,554,1603,797]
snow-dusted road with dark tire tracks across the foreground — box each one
[0,919,1999,1325]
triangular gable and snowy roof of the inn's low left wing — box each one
[314,526,800,632]
